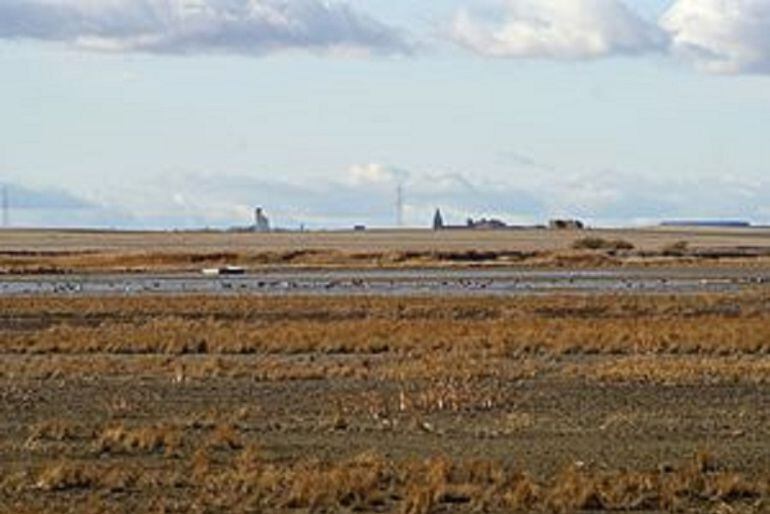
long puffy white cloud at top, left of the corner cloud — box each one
[452,0,666,59]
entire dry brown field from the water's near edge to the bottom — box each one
[0,290,770,514]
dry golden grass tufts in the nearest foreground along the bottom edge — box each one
[13,448,770,514]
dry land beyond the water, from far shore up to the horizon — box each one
[0,228,770,274]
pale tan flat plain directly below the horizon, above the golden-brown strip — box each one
[0,227,770,252]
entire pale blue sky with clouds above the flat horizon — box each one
[0,0,770,228]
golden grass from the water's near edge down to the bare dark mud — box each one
[0,292,770,390]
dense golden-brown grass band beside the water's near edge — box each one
[0,293,770,360]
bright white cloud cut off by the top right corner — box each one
[661,0,770,73]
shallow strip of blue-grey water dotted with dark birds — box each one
[0,269,770,296]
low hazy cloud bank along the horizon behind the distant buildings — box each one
[9,164,770,228]
